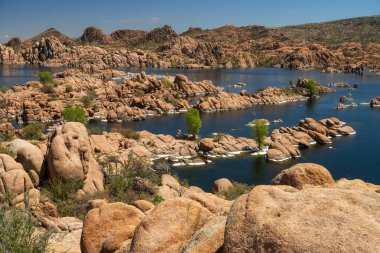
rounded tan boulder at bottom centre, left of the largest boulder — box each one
[130,198,212,253]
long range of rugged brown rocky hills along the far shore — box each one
[0,16,380,71]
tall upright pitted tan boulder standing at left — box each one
[48,122,104,194]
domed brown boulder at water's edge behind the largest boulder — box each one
[271,163,334,189]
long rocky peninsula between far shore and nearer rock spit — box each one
[0,69,333,123]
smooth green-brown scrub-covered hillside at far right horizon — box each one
[275,15,380,44]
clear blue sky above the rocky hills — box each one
[0,0,380,43]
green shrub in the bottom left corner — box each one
[0,206,50,253]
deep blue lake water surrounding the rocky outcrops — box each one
[0,66,380,190]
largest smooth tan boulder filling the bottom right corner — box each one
[223,183,380,253]
